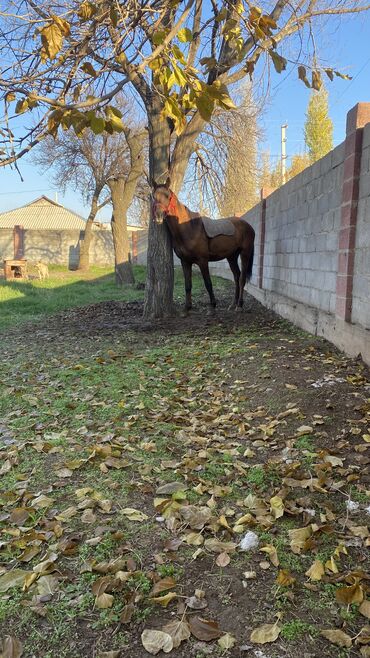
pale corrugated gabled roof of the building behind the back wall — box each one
[0,196,100,231]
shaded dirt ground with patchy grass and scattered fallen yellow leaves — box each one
[0,291,370,658]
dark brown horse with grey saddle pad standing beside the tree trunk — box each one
[153,179,254,311]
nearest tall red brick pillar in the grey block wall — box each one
[335,103,370,322]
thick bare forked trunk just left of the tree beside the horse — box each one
[107,130,144,285]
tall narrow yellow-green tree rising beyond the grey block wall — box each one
[304,87,333,164]
